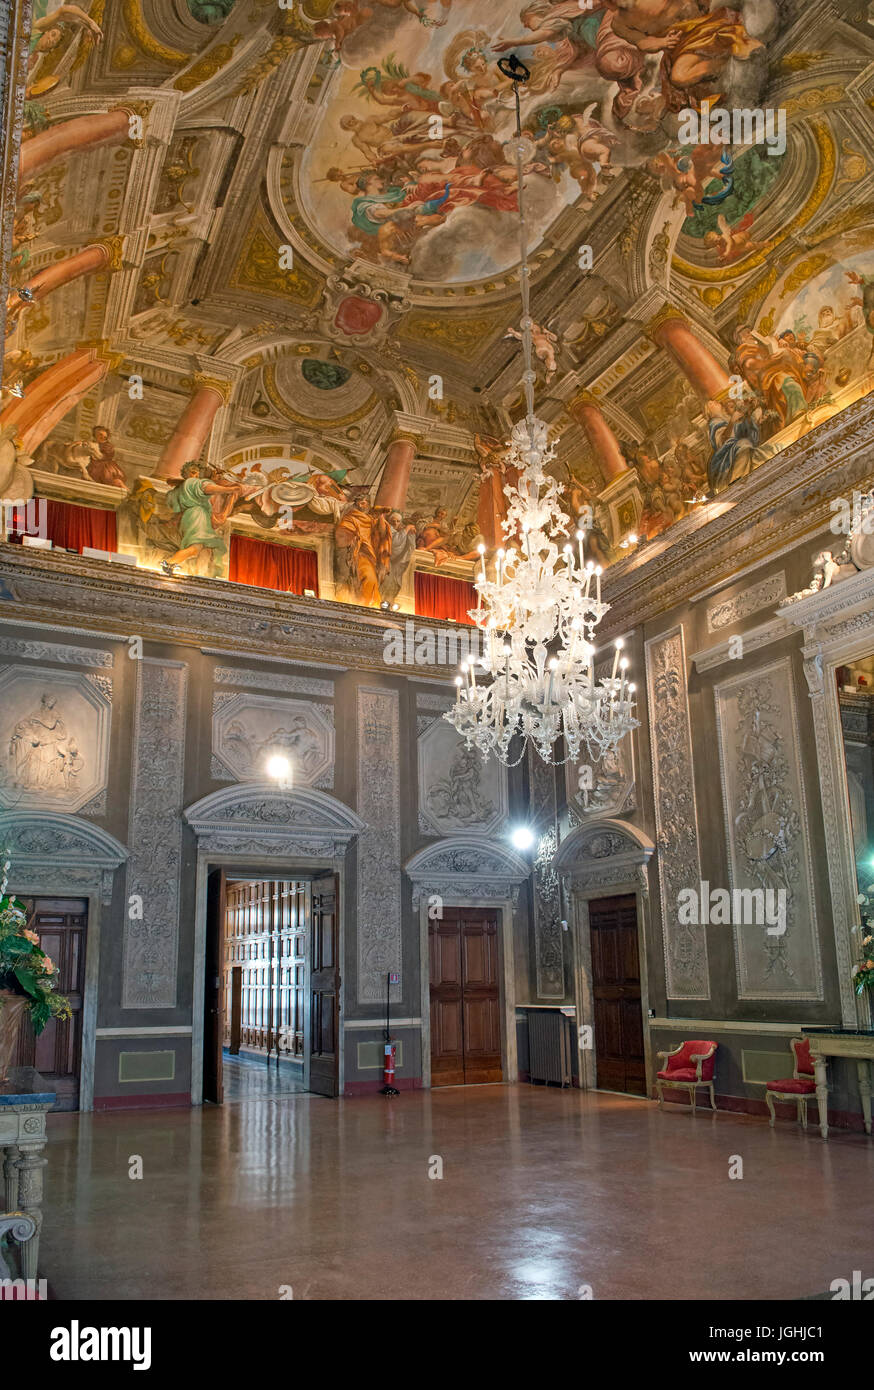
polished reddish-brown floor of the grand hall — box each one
[40,1086,874,1300]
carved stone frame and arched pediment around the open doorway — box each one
[183,781,365,1105]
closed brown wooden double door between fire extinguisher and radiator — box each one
[428,908,503,1086]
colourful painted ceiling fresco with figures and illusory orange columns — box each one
[0,0,874,607]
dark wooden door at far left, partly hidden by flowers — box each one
[13,898,88,1111]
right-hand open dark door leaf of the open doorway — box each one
[310,873,340,1095]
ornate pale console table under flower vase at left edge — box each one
[0,1066,56,1279]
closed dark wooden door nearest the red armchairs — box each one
[589,894,646,1095]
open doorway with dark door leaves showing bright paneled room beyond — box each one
[203,867,339,1105]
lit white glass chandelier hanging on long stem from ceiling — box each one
[443,56,638,766]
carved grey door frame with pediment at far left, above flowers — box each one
[0,809,128,1111]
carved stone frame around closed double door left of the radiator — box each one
[404,834,531,1088]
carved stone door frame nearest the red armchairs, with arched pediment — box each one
[556,817,656,1097]
